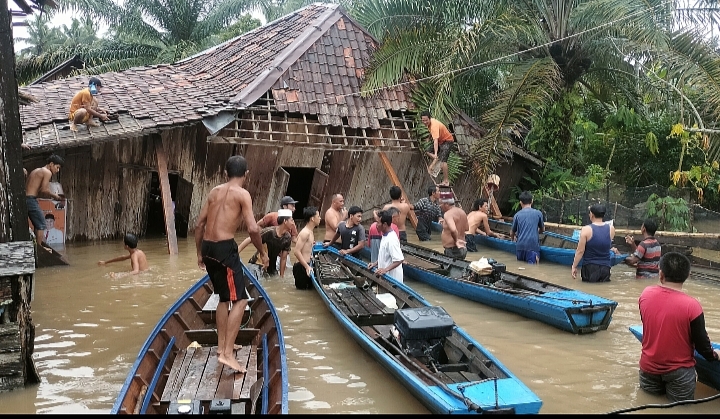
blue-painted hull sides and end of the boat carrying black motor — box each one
[313,245,542,414]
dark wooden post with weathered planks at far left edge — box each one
[0,0,40,392]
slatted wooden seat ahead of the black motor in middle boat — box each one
[328,287,395,326]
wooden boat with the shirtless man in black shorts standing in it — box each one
[111,266,288,414]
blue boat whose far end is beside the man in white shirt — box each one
[394,243,617,334]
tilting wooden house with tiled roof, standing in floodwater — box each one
[21,3,540,249]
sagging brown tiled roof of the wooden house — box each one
[20,3,411,149]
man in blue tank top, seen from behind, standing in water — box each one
[571,204,615,282]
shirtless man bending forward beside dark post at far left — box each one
[25,154,65,246]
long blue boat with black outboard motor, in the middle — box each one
[313,245,542,414]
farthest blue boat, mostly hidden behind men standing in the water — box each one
[473,220,628,266]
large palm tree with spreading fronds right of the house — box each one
[353,0,720,185]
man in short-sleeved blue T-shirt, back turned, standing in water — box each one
[510,191,545,264]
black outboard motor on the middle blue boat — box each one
[394,306,455,364]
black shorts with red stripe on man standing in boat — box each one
[200,239,248,303]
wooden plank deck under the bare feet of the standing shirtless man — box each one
[160,345,262,414]
